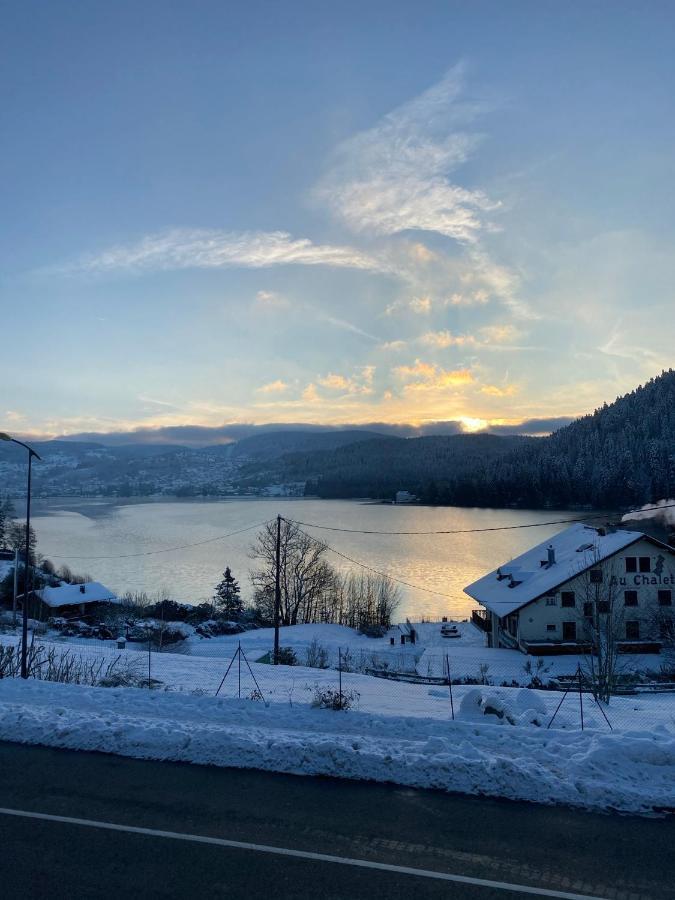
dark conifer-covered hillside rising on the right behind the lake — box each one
[298,369,675,508]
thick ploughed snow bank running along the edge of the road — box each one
[0,679,675,814]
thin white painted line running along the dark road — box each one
[0,807,606,900]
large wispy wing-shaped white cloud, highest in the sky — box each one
[315,66,497,243]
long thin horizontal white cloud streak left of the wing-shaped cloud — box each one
[64,229,390,274]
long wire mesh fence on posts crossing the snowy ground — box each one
[0,628,675,732]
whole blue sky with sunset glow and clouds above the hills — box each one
[0,0,675,436]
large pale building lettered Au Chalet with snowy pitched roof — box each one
[464,524,675,655]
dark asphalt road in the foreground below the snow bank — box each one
[0,743,675,900]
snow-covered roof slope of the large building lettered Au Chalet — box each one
[464,524,656,617]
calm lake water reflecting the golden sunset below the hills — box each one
[30,498,573,619]
